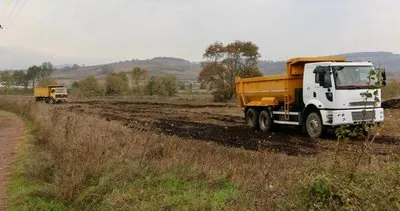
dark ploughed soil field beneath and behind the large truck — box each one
[60,100,400,155]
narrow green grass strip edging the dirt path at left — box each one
[7,119,69,211]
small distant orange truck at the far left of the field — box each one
[33,86,68,104]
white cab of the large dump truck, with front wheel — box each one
[303,62,384,135]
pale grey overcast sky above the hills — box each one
[0,0,400,67]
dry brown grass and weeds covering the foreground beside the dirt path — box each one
[0,98,400,210]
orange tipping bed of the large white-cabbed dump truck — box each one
[235,57,345,107]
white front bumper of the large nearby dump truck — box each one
[321,108,384,126]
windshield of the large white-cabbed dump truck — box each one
[332,66,376,89]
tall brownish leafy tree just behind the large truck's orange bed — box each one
[198,41,262,99]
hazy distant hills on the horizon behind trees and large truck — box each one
[49,52,400,83]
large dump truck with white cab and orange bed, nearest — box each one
[235,57,386,138]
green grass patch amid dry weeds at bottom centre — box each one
[104,171,238,210]
